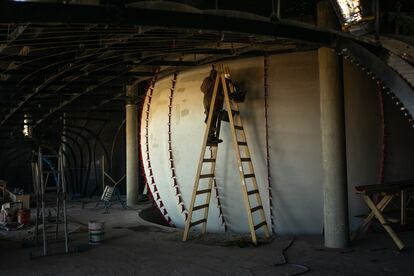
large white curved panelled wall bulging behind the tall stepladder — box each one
[141,52,372,234]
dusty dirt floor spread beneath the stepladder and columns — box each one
[0,203,414,275]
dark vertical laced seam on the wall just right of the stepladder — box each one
[263,56,276,234]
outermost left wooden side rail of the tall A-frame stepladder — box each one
[183,72,220,241]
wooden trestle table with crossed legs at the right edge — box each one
[351,180,414,250]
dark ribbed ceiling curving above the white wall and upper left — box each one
[0,0,413,148]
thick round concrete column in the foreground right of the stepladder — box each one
[318,1,349,248]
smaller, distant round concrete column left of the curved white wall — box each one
[125,87,139,206]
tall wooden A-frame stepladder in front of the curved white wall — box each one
[183,65,270,244]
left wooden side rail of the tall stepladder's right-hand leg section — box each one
[220,72,257,244]
